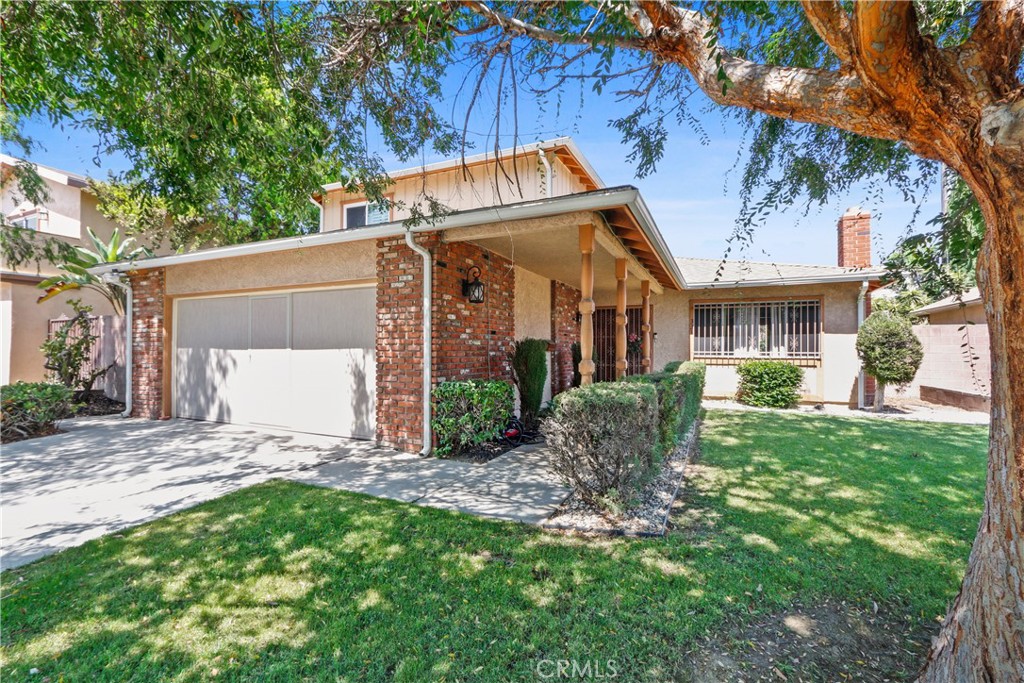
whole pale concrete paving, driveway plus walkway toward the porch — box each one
[0,417,568,568]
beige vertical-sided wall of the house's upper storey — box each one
[324,154,584,231]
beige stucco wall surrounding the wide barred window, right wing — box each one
[647,283,860,403]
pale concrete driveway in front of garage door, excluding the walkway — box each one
[0,417,391,569]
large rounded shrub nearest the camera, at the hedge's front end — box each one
[544,382,658,510]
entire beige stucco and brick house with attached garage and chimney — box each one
[95,137,880,451]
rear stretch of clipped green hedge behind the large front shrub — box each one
[627,361,705,456]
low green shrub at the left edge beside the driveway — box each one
[0,382,74,442]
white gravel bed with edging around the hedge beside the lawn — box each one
[542,420,700,537]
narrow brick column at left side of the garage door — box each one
[129,268,164,420]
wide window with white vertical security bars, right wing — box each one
[693,300,821,358]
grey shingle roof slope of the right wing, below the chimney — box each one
[676,257,884,289]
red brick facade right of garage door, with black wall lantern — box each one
[377,234,515,451]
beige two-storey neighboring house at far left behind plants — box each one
[0,155,124,386]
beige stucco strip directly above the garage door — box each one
[166,240,377,296]
